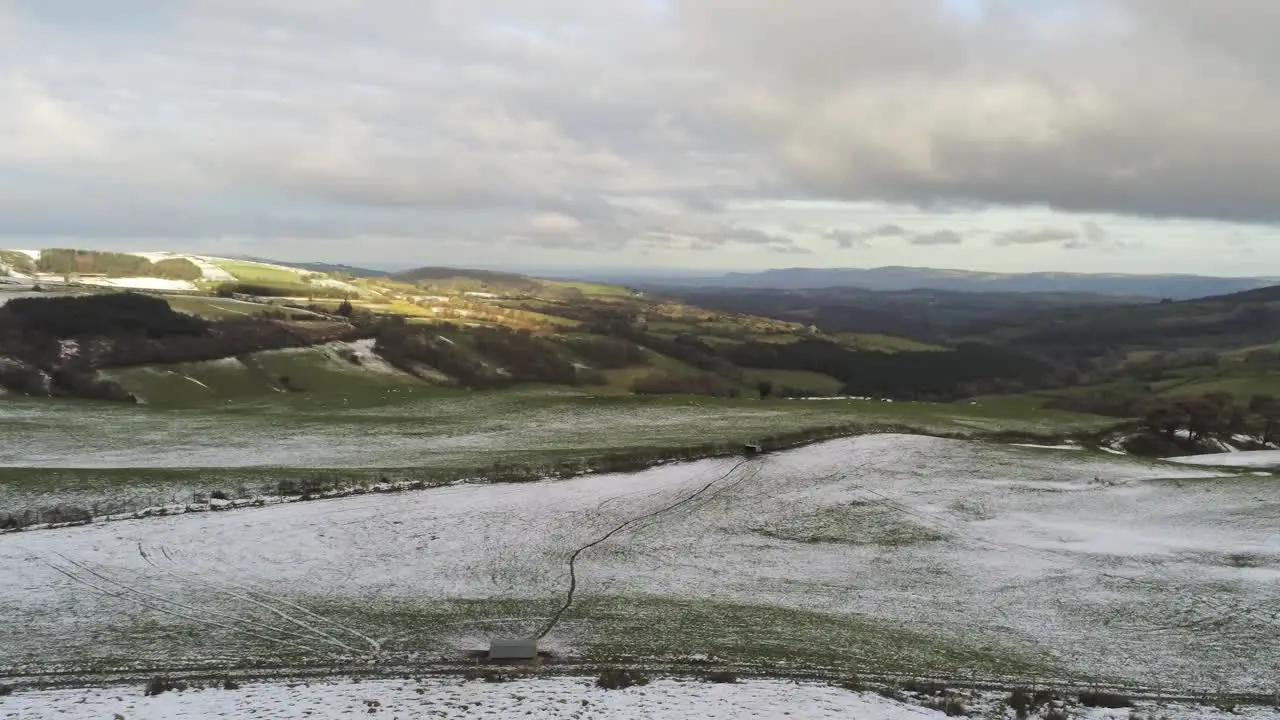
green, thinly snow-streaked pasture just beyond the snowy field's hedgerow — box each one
[0,358,1112,512]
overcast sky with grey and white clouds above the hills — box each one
[0,0,1280,274]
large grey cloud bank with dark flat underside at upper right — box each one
[681,0,1280,222]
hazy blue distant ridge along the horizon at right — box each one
[643,266,1280,300]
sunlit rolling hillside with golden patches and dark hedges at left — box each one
[0,250,967,405]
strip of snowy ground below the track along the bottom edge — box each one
[0,678,1280,720]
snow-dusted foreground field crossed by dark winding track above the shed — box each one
[0,434,1280,691]
